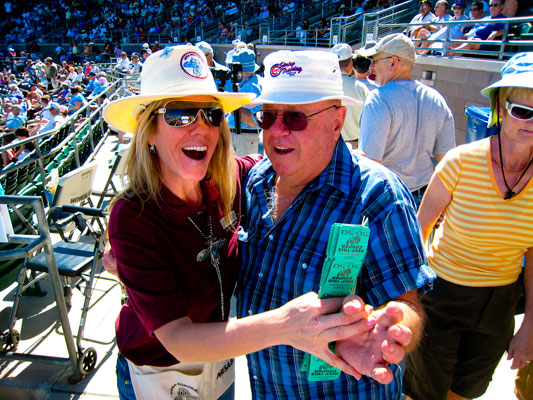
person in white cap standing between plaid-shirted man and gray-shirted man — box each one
[331,43,369,149]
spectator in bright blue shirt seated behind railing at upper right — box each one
[448,0,507,55]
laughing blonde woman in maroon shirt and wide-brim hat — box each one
[104,46,369,399]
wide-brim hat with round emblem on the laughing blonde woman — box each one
[103,45,255,133]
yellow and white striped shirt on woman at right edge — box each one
[429,138,533,287]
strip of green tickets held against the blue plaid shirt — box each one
[300,217,370,381]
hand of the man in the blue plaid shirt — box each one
[336,301,413,384]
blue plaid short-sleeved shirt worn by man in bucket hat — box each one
[237,140,435,400]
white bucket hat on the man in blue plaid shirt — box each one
[252,50,361,105]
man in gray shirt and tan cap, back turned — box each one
[359,33,455,205]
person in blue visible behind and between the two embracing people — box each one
[224,48,263,156]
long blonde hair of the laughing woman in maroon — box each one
[111,99,237,226]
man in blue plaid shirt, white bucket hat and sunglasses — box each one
[237,51,435,399]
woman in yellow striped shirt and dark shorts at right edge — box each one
[404,52,533,399]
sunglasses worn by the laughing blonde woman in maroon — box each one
[154,101,224,128]
